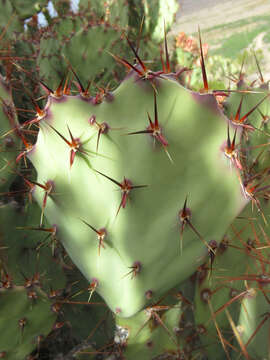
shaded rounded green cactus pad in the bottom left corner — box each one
[0,286,56,360]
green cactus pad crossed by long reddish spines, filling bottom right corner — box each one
[195,200,270,359]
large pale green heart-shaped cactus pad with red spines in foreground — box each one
[27,70,247,317]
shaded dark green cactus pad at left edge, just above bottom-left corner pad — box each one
[0,202,66,292]
